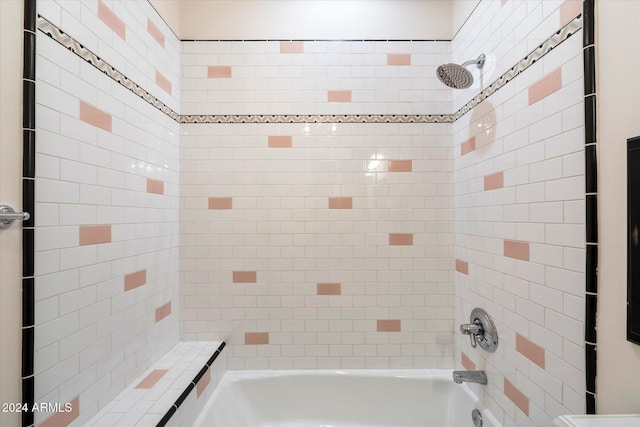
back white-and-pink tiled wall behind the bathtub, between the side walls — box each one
[180,41,454,369]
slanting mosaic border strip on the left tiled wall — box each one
[38,15,180,121]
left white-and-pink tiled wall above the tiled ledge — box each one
[35,0,179,425]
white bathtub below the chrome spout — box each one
[194,370,500,427]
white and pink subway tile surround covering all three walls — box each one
[27,0,584,426]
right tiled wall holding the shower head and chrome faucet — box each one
[453,1,585,427]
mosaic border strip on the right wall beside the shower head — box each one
[453,14,582,122]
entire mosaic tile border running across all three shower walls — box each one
[37,14,582,123]
